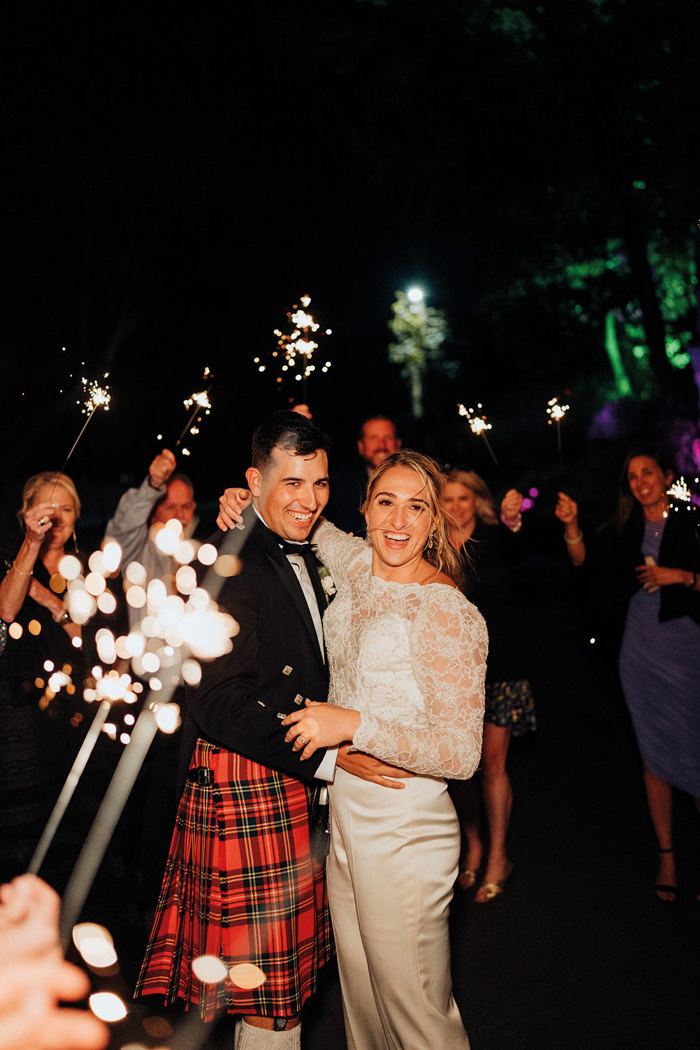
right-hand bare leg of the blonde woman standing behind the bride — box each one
[476,722,513,900]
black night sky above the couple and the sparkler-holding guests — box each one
[0,0,700,530]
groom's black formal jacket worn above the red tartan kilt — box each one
[183,507,328,782]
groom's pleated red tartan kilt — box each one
[134,739,334,1021]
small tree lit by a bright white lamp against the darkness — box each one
[388,288,454,419]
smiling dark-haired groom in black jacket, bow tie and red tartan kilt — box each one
[139,412,405,1050]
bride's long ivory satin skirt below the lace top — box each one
[326,770,469,1050]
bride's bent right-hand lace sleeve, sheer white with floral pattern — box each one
[354,586,488,780]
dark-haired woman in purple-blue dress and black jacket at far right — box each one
[556,449,700,902]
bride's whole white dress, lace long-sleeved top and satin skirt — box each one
[314,523,487,1050]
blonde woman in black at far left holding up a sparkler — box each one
[0,471,83,879]
